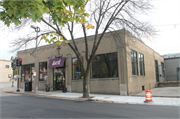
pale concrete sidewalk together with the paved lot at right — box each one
[1,83,180,106]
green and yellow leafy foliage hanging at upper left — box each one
[0,0,89,45]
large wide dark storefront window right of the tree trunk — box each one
[91,53,118,78]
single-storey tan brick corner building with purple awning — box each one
[18,30,164,95]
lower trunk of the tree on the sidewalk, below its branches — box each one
[83,67,90,98]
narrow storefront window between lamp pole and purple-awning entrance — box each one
[39,62,47,81]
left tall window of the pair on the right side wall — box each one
[131,49,139,76]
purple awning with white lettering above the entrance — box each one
[48,57,66,68]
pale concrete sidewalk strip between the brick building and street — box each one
[3,87,180,106]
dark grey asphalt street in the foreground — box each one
[0,89,180,119]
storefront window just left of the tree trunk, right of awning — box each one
[72,58,83,80]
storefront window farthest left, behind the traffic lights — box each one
[21,64,34,81]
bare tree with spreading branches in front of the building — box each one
[3,0,155,98]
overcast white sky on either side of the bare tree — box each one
[0,0,180,60]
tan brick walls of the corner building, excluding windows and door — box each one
[18,30,164,95]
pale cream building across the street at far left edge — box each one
[0,60,12,82]
